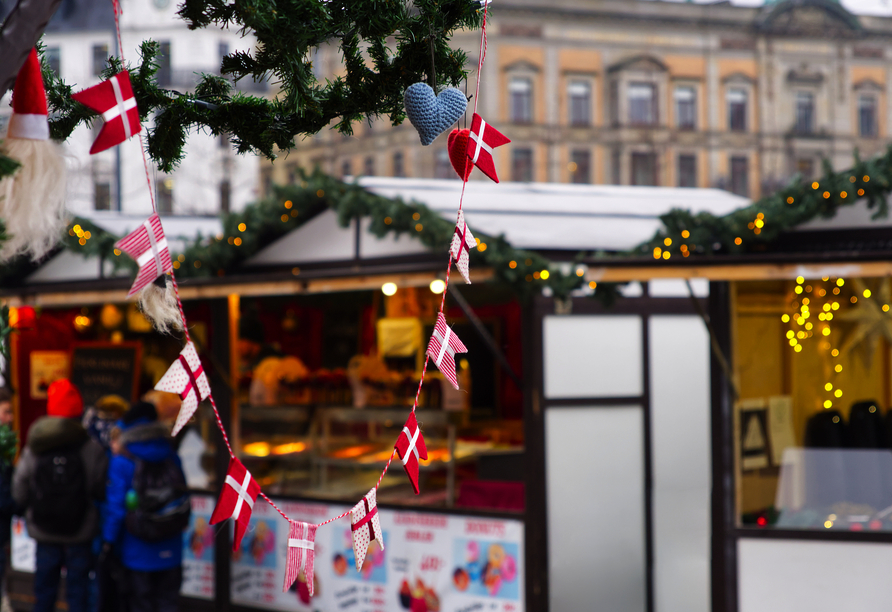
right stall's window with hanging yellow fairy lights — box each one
[733,276,892,532]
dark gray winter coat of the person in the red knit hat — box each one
[12,416,108,544]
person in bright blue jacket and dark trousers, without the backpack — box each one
[102,402,183,612]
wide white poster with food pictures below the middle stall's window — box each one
[232,500,524,612]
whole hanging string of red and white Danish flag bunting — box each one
[102,0,510,596]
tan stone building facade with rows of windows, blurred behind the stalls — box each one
[262,0,892,198]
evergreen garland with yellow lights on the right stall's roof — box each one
[630,147,892,260]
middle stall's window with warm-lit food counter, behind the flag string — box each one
[236,281,523,511]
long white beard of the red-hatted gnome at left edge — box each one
[0,138,68,261]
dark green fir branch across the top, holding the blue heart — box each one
[44,0,482,172]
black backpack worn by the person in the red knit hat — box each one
[31,444,90,536]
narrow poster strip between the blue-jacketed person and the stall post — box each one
[180,495,215,599]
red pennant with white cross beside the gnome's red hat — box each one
[71,70,142,155]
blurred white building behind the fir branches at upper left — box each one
[0,0,265,215]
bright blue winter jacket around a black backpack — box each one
[102,421,183,572]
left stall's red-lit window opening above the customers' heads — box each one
[10,302,220,490]
